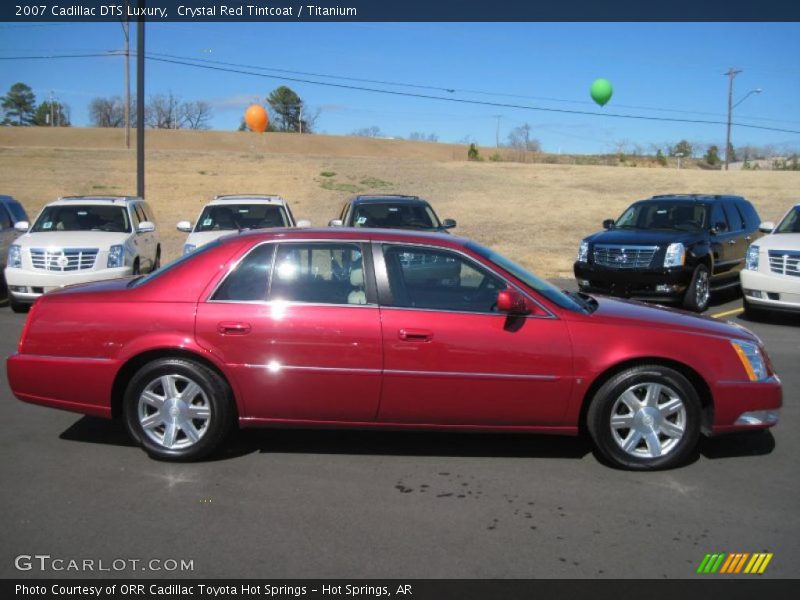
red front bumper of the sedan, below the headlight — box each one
[711,376,783,435]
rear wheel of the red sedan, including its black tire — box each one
[123,358,235,462]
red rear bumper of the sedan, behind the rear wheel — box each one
[6,354,119,418]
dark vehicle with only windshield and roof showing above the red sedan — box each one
[328,194,456,231]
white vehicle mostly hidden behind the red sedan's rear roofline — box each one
[178,194,311,254]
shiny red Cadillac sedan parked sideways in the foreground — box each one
[7,228,781,469]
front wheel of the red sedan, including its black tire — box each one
[586,365,701,471]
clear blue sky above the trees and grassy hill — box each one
[0,22,800,153]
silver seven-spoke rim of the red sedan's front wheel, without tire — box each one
[610,382,686,458]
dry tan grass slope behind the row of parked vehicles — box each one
[0,128,800,277]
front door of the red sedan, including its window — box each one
[374,244,572,426]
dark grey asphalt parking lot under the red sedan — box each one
[0,288,800,578]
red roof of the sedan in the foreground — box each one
[216,227,470,248]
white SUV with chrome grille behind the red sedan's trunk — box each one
[5,196,161,312]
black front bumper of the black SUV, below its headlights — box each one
[573,262,692,302]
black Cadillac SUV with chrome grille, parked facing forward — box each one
[574,194,761,312]
